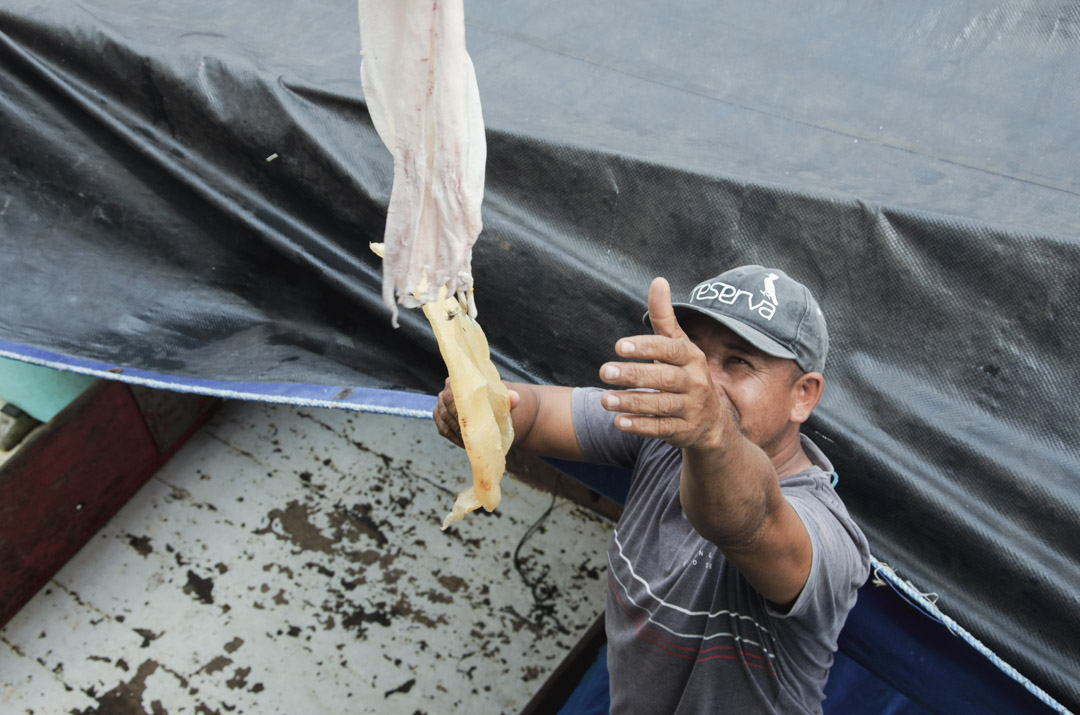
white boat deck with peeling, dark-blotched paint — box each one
[0,403,611,715]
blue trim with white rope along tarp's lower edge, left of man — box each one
[0,339,436,419]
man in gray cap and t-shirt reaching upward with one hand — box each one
[434,266,869,713]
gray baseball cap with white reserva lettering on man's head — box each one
[644,266,828,373]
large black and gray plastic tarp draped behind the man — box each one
[0,0,1080,709]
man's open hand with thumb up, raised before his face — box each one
[600,278,725,447]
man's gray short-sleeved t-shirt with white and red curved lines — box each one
[572,388,869,713]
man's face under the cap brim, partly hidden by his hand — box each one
[679,315,801,457]
